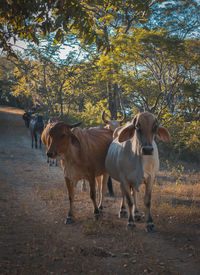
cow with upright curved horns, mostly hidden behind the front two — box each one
[101,110,126,197]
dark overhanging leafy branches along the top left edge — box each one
[0,0,151,54]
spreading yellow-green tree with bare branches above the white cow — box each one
[104,28,200,119]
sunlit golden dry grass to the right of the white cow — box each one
[152,164,200,229]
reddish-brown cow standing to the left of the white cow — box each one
[47,122,112,223]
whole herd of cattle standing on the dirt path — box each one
[23,111,170,232]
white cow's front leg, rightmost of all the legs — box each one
[144,179,156,232]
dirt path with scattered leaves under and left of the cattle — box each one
[0,107,200,275]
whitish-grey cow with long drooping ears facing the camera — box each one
[105,112,170,232]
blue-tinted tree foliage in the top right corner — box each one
[143,0,200,39]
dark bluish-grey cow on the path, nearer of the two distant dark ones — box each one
[29,115,44,149]
